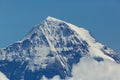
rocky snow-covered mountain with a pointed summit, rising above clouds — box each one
[0,17,120,80]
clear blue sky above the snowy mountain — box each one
[0,0,120,51]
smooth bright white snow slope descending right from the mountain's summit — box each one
[41,17,114,61]
